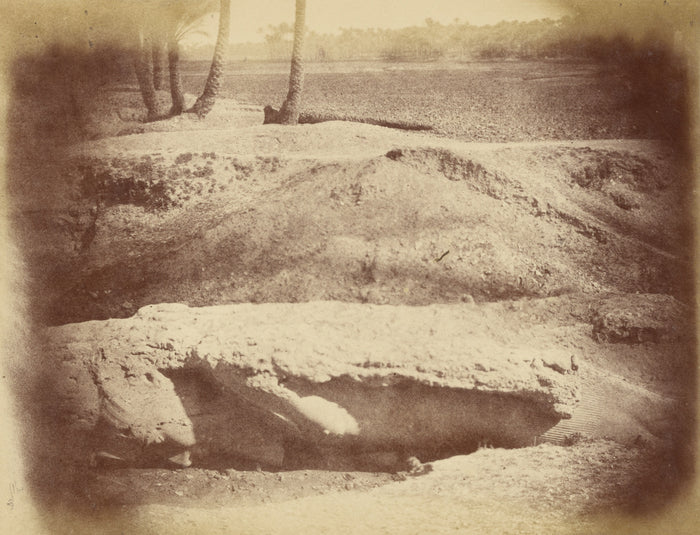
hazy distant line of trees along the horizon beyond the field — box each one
[188,17,684,61]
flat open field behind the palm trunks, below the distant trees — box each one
[184,61,679,142]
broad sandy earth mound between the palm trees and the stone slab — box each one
[13,123,691,323]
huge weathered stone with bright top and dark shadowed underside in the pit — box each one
[46,302,578,467]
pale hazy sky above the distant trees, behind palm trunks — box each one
[189,0,566,43]
